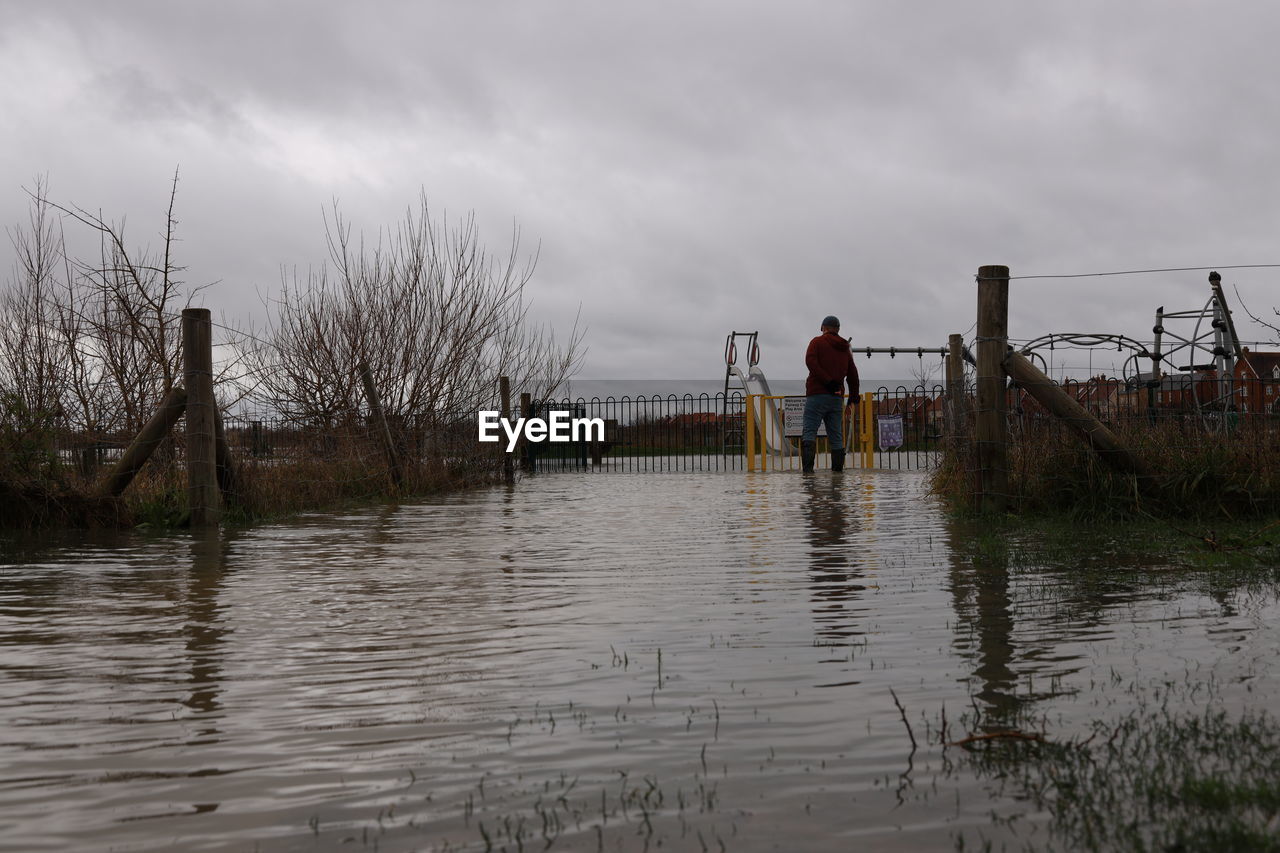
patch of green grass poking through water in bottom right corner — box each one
[957,706,1280,853]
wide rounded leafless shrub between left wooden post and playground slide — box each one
[244,195,582,425]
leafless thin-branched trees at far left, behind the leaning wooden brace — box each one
[0,172,195,433]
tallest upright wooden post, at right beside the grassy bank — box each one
[974,265,1009,512]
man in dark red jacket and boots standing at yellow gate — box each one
[800,316,858,474]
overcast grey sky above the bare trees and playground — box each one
[0,0,1280,378]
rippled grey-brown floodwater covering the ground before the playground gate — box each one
[0,471,1280,850]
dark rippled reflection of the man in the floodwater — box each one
[804,474,869,640]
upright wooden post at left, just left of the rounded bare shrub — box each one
[182,309,221,529]
